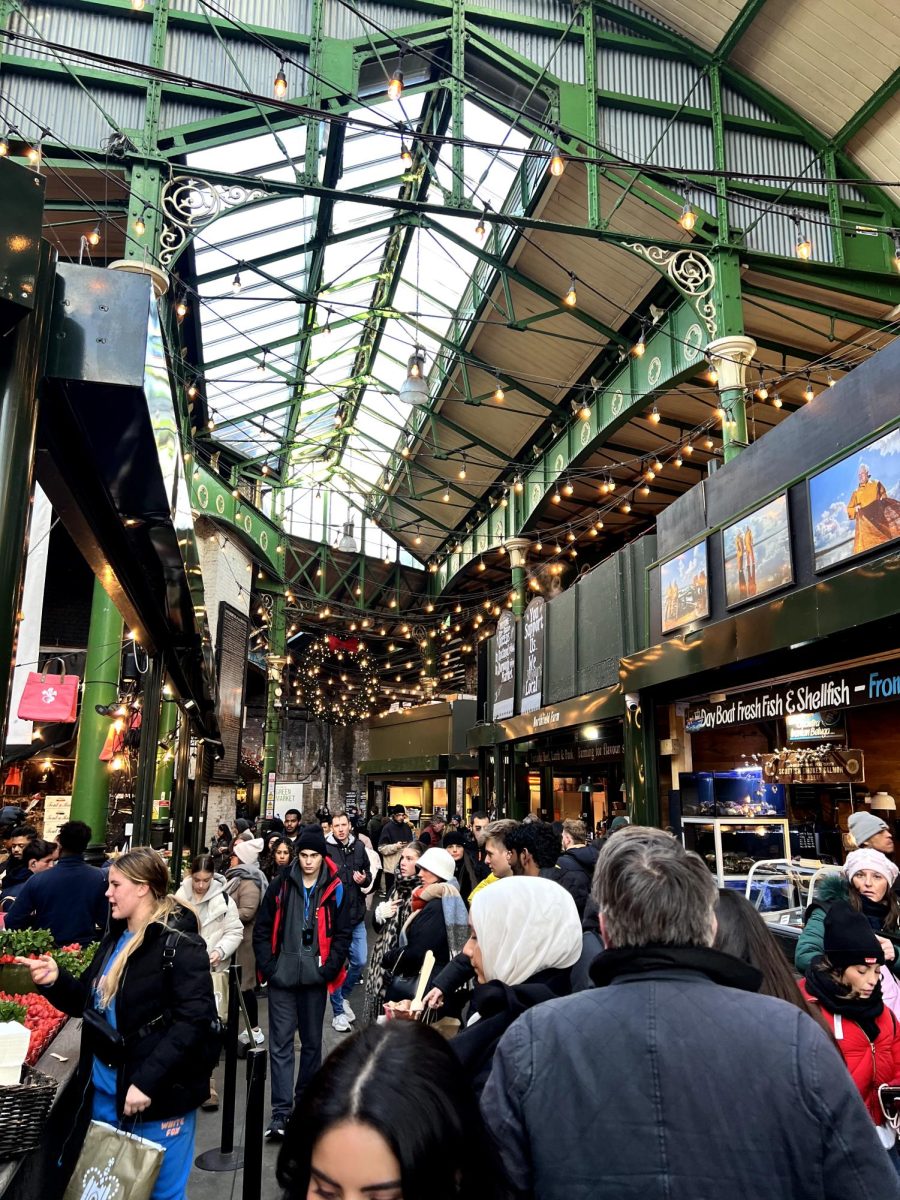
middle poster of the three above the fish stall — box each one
[722,496,793,608]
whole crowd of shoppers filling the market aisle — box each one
[0,808,900,1200]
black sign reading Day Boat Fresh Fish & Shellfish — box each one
[684,659,900,733]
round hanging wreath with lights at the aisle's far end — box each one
[296,637,379,725]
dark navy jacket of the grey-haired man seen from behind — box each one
[481,947,900,1200]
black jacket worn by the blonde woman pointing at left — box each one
[38,907,216,1121]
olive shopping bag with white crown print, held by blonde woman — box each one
[62,1121,166,1200]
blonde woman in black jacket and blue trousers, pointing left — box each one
[18,846,217,1200]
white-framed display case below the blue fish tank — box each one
[682,817,791,912]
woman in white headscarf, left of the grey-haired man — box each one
[450,875,581,1096]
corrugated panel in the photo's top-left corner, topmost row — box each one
[5,4,151,62]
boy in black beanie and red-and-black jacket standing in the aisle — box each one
[253,828,353,1138]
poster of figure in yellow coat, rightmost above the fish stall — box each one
[809,430,900,571]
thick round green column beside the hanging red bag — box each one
[71,578,124,858]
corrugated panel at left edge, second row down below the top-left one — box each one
[4,72,144,150]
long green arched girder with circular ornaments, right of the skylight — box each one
[432,301,707,594]
